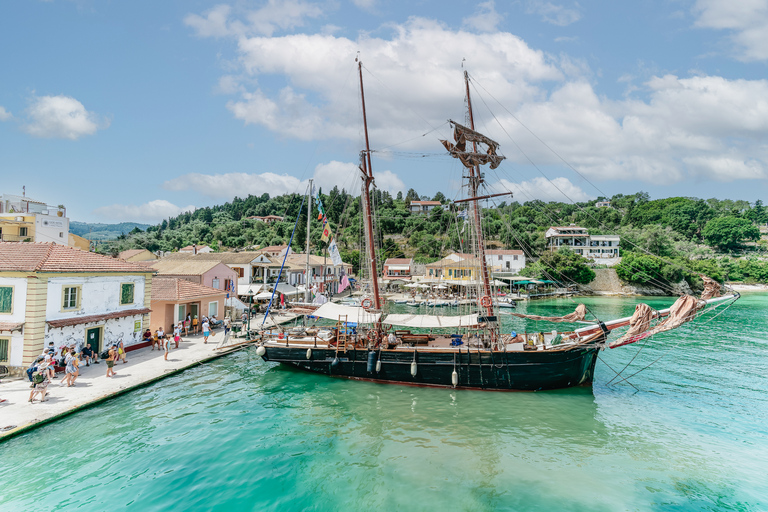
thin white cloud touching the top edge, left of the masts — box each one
[184,0,323,37]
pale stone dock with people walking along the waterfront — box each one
[0,314,298,442]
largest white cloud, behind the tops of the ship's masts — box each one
[222,18,564,143]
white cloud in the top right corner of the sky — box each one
[693,0,768,61]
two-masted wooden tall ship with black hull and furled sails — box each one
[257,60,739,391]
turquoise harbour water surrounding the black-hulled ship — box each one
[0,294,768,511]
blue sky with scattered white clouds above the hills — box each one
[0,0,768,222]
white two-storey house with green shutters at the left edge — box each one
[0,242,154,370]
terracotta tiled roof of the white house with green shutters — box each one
[0,242,153,273]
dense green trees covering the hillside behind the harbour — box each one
[103,188,768,283]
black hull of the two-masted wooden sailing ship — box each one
[262,345,599,391]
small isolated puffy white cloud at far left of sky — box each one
[23,95,109,140]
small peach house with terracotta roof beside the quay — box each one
[151,277,227,332]
